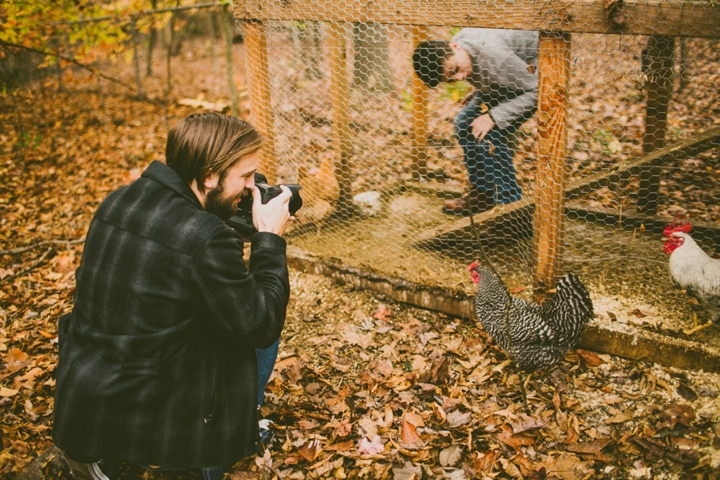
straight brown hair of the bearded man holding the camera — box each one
[165,112,265,192]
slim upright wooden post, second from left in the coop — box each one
[328,23,353,213]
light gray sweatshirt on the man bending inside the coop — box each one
[451,28,538,128]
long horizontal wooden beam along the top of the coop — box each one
[235,0,720,38]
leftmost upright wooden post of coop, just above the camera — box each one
[244,20,277,185]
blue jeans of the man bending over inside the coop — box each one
[454,99,522,203]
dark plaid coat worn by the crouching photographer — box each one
[53,162,290,467]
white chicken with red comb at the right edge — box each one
[663,222,720,322]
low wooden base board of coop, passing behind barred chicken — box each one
[288,250,720,373]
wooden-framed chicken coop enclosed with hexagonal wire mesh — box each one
[234,0,720,371]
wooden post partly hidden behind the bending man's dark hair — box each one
[410,25,428,180]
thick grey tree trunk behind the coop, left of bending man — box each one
[353,23,394,92]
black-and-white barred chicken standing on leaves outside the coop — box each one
[468,263,594,371]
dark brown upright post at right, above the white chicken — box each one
[638,35,675,215]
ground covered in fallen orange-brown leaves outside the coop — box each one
[0,31,720,480]
